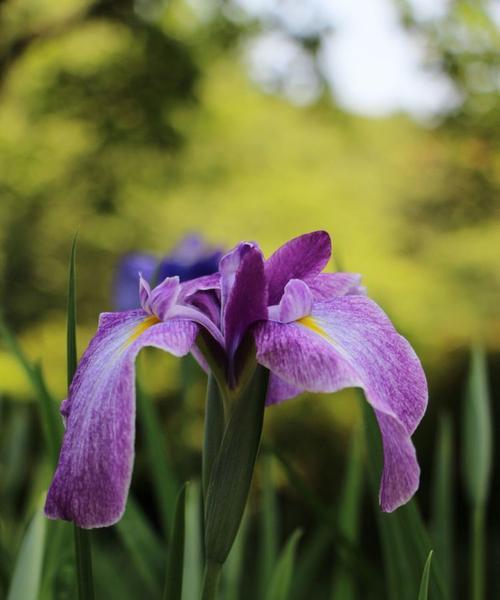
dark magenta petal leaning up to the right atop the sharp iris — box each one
[265,231,332,305]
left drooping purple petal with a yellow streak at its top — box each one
[45,310,199,528]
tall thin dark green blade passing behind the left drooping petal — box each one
[66,235,94,600]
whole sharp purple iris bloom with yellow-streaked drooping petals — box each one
[45,231,427,528]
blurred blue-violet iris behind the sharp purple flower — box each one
[114,234,222,310]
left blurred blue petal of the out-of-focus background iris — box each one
[113,254,158,310]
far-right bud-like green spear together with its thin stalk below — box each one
[463,347,492,600]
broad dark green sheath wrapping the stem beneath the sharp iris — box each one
[205,365,269,564]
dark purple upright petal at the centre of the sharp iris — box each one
[219,242,267,358]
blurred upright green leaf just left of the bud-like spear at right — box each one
[432,415,455,598]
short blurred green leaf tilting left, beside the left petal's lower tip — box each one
[116,496,164,597]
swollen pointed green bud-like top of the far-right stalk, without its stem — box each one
[463,347,492,506]
